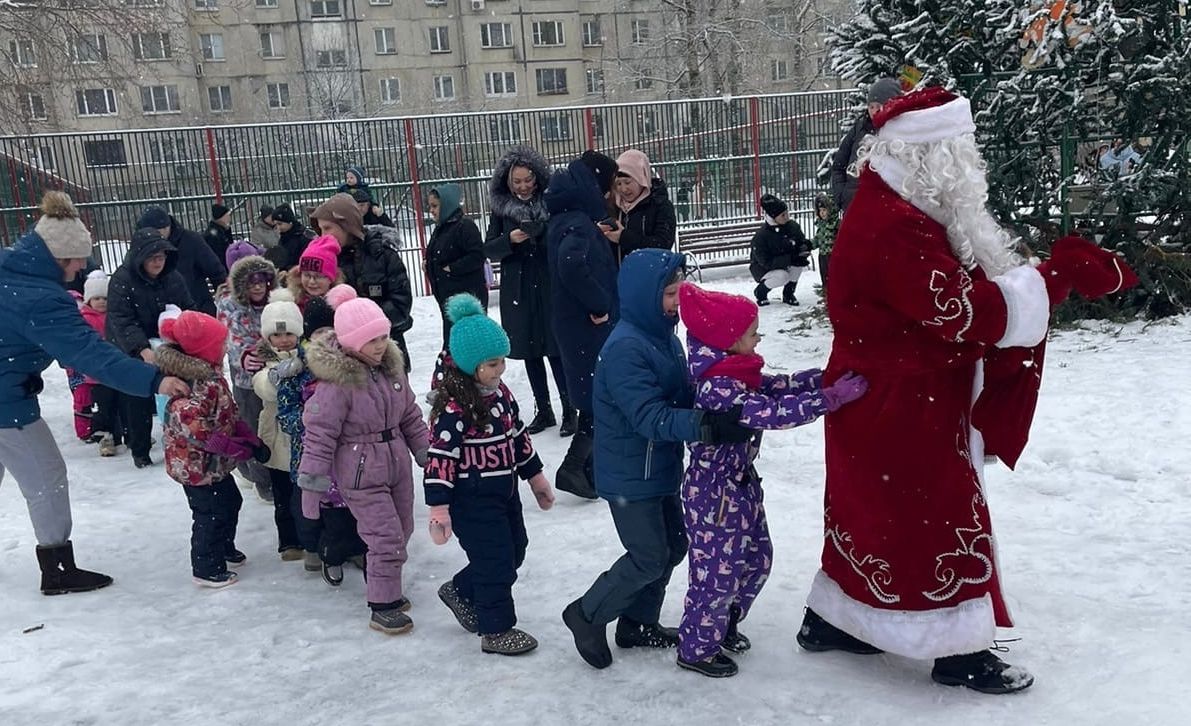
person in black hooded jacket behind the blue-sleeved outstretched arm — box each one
[106,227,194,468]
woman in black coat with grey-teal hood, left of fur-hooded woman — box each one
[425,183,488,350]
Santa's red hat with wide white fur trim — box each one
[873,86,975,144]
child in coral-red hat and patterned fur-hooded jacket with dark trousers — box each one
[156,311,269,588]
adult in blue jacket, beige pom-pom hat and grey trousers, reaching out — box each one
[0,192,187,595]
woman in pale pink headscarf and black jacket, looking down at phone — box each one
[600,149,678,267]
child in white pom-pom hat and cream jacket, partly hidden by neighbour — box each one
[252,290,303,562]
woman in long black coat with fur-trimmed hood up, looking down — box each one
[484,146,575,436]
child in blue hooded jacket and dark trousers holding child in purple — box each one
[562,249,750,668]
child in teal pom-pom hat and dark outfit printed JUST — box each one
[425,293,554,656]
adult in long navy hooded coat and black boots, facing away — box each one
[543,150,619,499]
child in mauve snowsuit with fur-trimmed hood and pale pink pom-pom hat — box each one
[298,298,430,636]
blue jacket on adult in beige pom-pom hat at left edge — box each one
[0,232,162,428]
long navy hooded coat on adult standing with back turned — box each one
[542,159,618,412]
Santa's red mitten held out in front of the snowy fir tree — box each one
[1039,234,1137,305]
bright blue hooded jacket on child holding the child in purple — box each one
[594,249,703,501]
